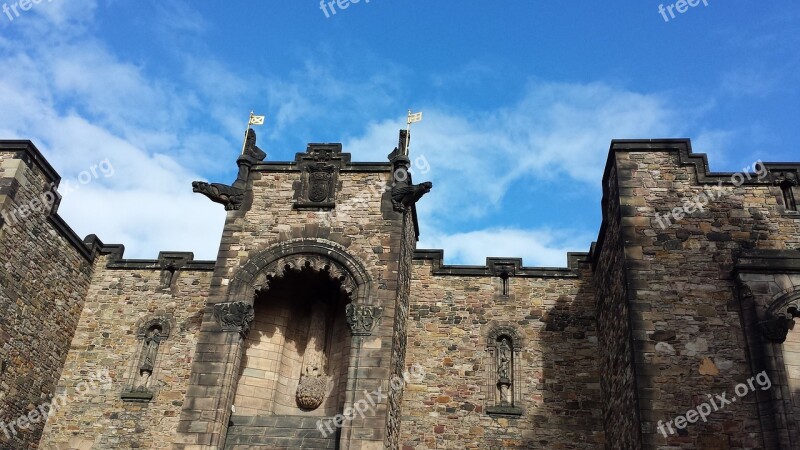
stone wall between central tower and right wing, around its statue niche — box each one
[401,255,603,450]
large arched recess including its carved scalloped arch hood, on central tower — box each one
[227,240,372,422]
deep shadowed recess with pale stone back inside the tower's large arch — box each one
[234,263,351,416]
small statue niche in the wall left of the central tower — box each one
[122,317,170,402]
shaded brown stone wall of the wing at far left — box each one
[0,141,92,450]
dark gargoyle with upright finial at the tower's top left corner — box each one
[192,128,267,211]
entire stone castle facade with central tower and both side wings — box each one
[0,132,800,450]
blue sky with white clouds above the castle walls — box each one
[0,0,800,266]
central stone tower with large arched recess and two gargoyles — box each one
[171,130,430,449]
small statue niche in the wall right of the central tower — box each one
[486,327,522,415]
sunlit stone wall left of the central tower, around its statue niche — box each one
[40,254,211,449]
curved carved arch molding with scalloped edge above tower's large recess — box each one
[227,239,373,304]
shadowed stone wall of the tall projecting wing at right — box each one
[612,141,800,449]
